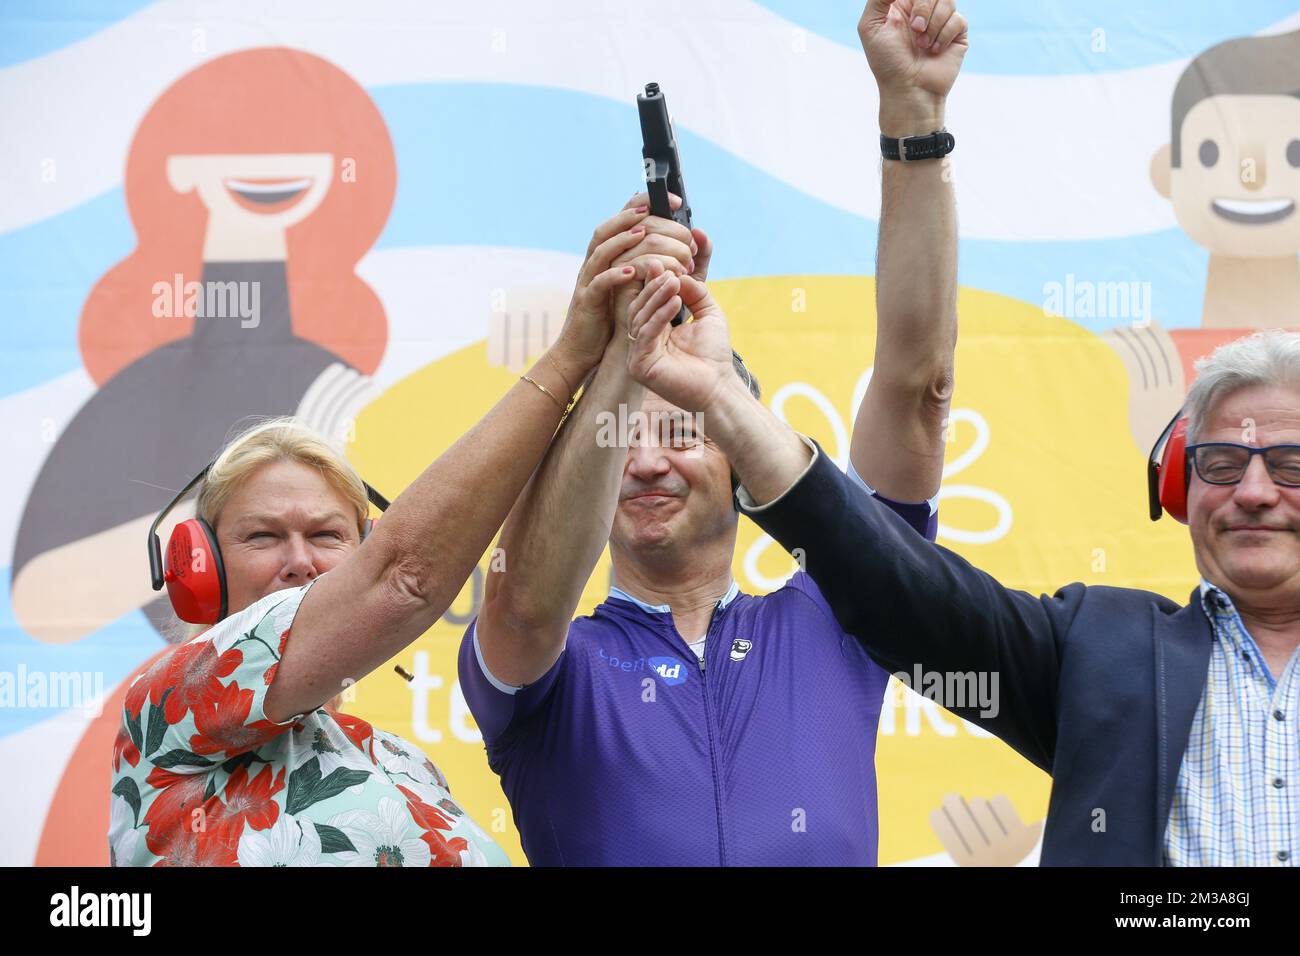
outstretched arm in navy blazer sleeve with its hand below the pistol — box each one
[629,267,1066,767]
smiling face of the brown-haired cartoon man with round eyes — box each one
[1151,95,1300,259]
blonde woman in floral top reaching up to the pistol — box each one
[109,195,690,866]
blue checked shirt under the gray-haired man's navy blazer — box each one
[1165,580,1300,866]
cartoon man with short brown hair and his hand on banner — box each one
[1106,31,1300,451]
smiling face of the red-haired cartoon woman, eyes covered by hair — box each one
[166,152,334,230]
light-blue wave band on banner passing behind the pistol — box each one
[0,83,1205,395]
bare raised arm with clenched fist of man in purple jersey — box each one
[850,0,967,501]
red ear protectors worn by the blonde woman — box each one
[148,464,389,624]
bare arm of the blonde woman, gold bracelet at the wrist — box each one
[265,235,636,722]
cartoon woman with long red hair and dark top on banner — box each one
[13,48,397,643]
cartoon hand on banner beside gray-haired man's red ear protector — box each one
[1101,323,1187,451]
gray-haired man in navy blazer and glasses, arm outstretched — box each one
[618,287,1300,866]
